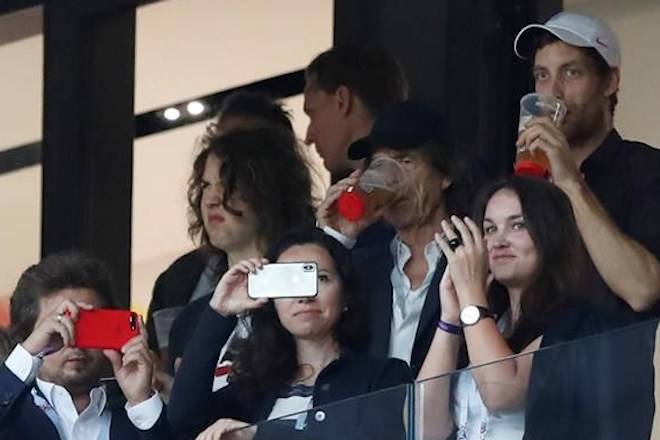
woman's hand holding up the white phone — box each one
[209,258,268,316]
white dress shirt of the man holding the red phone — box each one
[5,344,163,440]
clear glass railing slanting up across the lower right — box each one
[187,321,660,440]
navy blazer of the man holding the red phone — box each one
[0,364,172,440]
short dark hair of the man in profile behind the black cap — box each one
[305,46,408,117]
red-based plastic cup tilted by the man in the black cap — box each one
[337,156,406,222]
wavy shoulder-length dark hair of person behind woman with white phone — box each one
[188,127,314,248]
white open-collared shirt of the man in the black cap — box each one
[389,236,442,363]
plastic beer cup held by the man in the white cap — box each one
[514,93,566,178]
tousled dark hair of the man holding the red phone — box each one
[9,251,116,342]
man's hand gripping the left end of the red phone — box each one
[21,299,93,356]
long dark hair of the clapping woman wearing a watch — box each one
[474,176,589,351]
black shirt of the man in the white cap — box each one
[580,130,660,315]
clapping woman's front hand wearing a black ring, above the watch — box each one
[438,216,488,307]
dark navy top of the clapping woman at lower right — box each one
[524,303,658,440]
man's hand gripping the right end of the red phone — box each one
[103,320,154,406]
